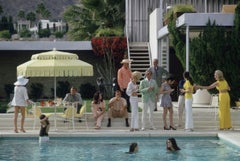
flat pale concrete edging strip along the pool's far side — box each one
[0,130,240,147]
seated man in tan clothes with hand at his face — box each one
[107,90,129,127]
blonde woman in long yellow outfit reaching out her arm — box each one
[197,70,232,130]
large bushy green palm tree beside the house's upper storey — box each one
[64,0,125,40]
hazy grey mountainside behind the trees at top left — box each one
[0,0,79,20]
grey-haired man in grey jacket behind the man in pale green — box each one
[148,59,168,111]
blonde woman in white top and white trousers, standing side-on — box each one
[126,71,142,131]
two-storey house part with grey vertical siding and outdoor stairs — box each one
[126,0,238,74]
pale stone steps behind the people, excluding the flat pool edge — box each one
[0,109,240,130]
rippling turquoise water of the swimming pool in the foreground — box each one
[0,137,240,161]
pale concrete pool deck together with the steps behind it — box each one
[0,108,240,147]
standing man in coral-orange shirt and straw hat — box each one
[117,59,132,112]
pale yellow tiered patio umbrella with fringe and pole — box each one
[17,49,93,129]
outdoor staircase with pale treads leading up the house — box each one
[129,42,151,75]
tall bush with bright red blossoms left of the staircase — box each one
[92,37,127,99]
